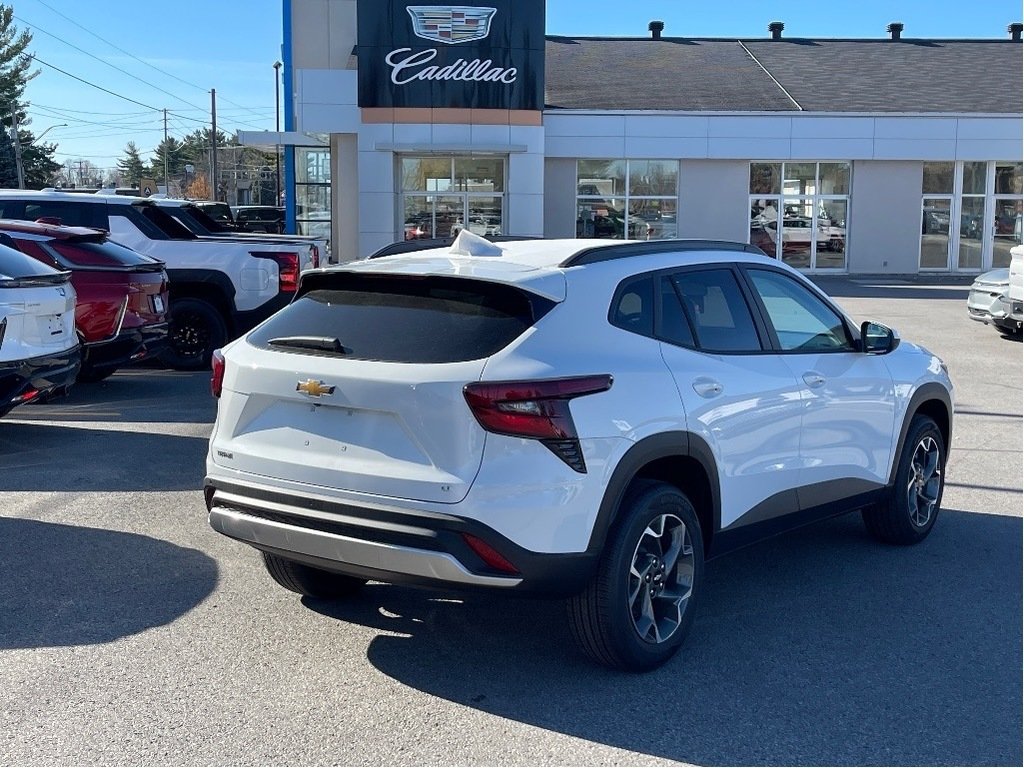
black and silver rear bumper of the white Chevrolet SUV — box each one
[206,478,597,596]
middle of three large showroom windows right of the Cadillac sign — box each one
[750,162,851,270]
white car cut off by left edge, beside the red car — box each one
[0,236,81,416]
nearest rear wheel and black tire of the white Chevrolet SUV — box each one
[568,482,703,672]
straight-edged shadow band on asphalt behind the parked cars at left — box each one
[0,419,209,493]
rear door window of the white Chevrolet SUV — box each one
[672,269,761,352]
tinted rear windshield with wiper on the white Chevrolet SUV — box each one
[249,273,553,364]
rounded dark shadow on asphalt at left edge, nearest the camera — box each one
[0,517,218,649]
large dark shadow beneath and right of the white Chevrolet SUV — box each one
[305,511,1022,765]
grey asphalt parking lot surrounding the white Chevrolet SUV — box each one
[0,280,1024,765]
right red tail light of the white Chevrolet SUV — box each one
[463,374,612,472]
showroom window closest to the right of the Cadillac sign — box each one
[577,160,679,240]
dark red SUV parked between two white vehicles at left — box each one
[0,220,168,381]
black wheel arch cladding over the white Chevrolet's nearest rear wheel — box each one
[587,431,722,556]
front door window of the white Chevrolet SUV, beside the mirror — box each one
[749,269,853,352]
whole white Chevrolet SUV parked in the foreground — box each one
[206,231,952,670]
